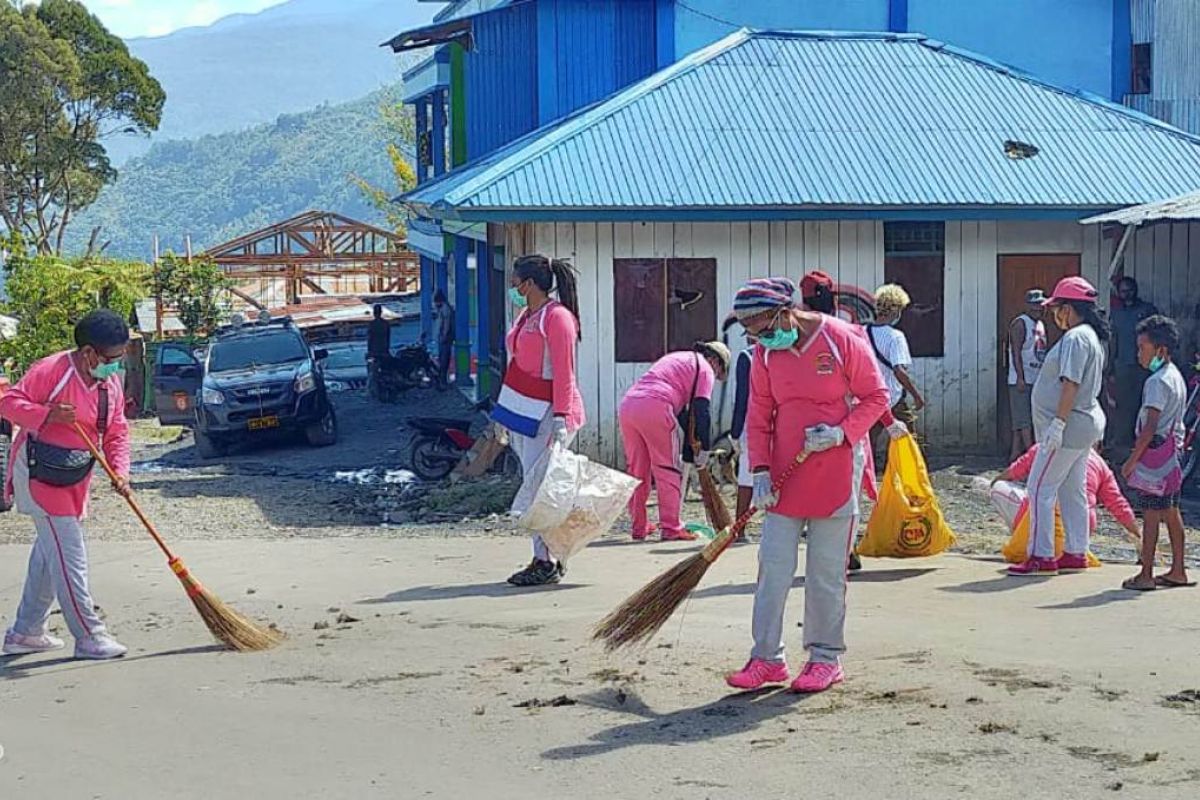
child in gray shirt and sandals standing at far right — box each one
[1121,314,1194,591]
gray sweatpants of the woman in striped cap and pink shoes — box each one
[750,513,858,662]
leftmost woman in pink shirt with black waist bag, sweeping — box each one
[0,311,130,658]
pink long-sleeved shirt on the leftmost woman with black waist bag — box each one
[0,353,130,517]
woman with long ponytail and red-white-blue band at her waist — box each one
[492,255,584,587]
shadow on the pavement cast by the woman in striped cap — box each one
[541,687,814,760]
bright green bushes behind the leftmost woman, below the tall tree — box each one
[0,242,150,371]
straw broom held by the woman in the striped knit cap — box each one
[592,450,809,651]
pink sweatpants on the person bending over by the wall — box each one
[618,397,683,536]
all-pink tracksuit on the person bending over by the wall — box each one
[617,350,716,537]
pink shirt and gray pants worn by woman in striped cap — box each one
[748,317,888,662]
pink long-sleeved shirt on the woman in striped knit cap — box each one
[746,317,888,518]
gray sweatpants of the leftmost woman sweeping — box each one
[12,449,104,639]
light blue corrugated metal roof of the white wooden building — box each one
[400,30,1200,222]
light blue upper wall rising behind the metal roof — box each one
[674,0,1128,101]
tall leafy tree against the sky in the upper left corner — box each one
[0,0,166,254]
